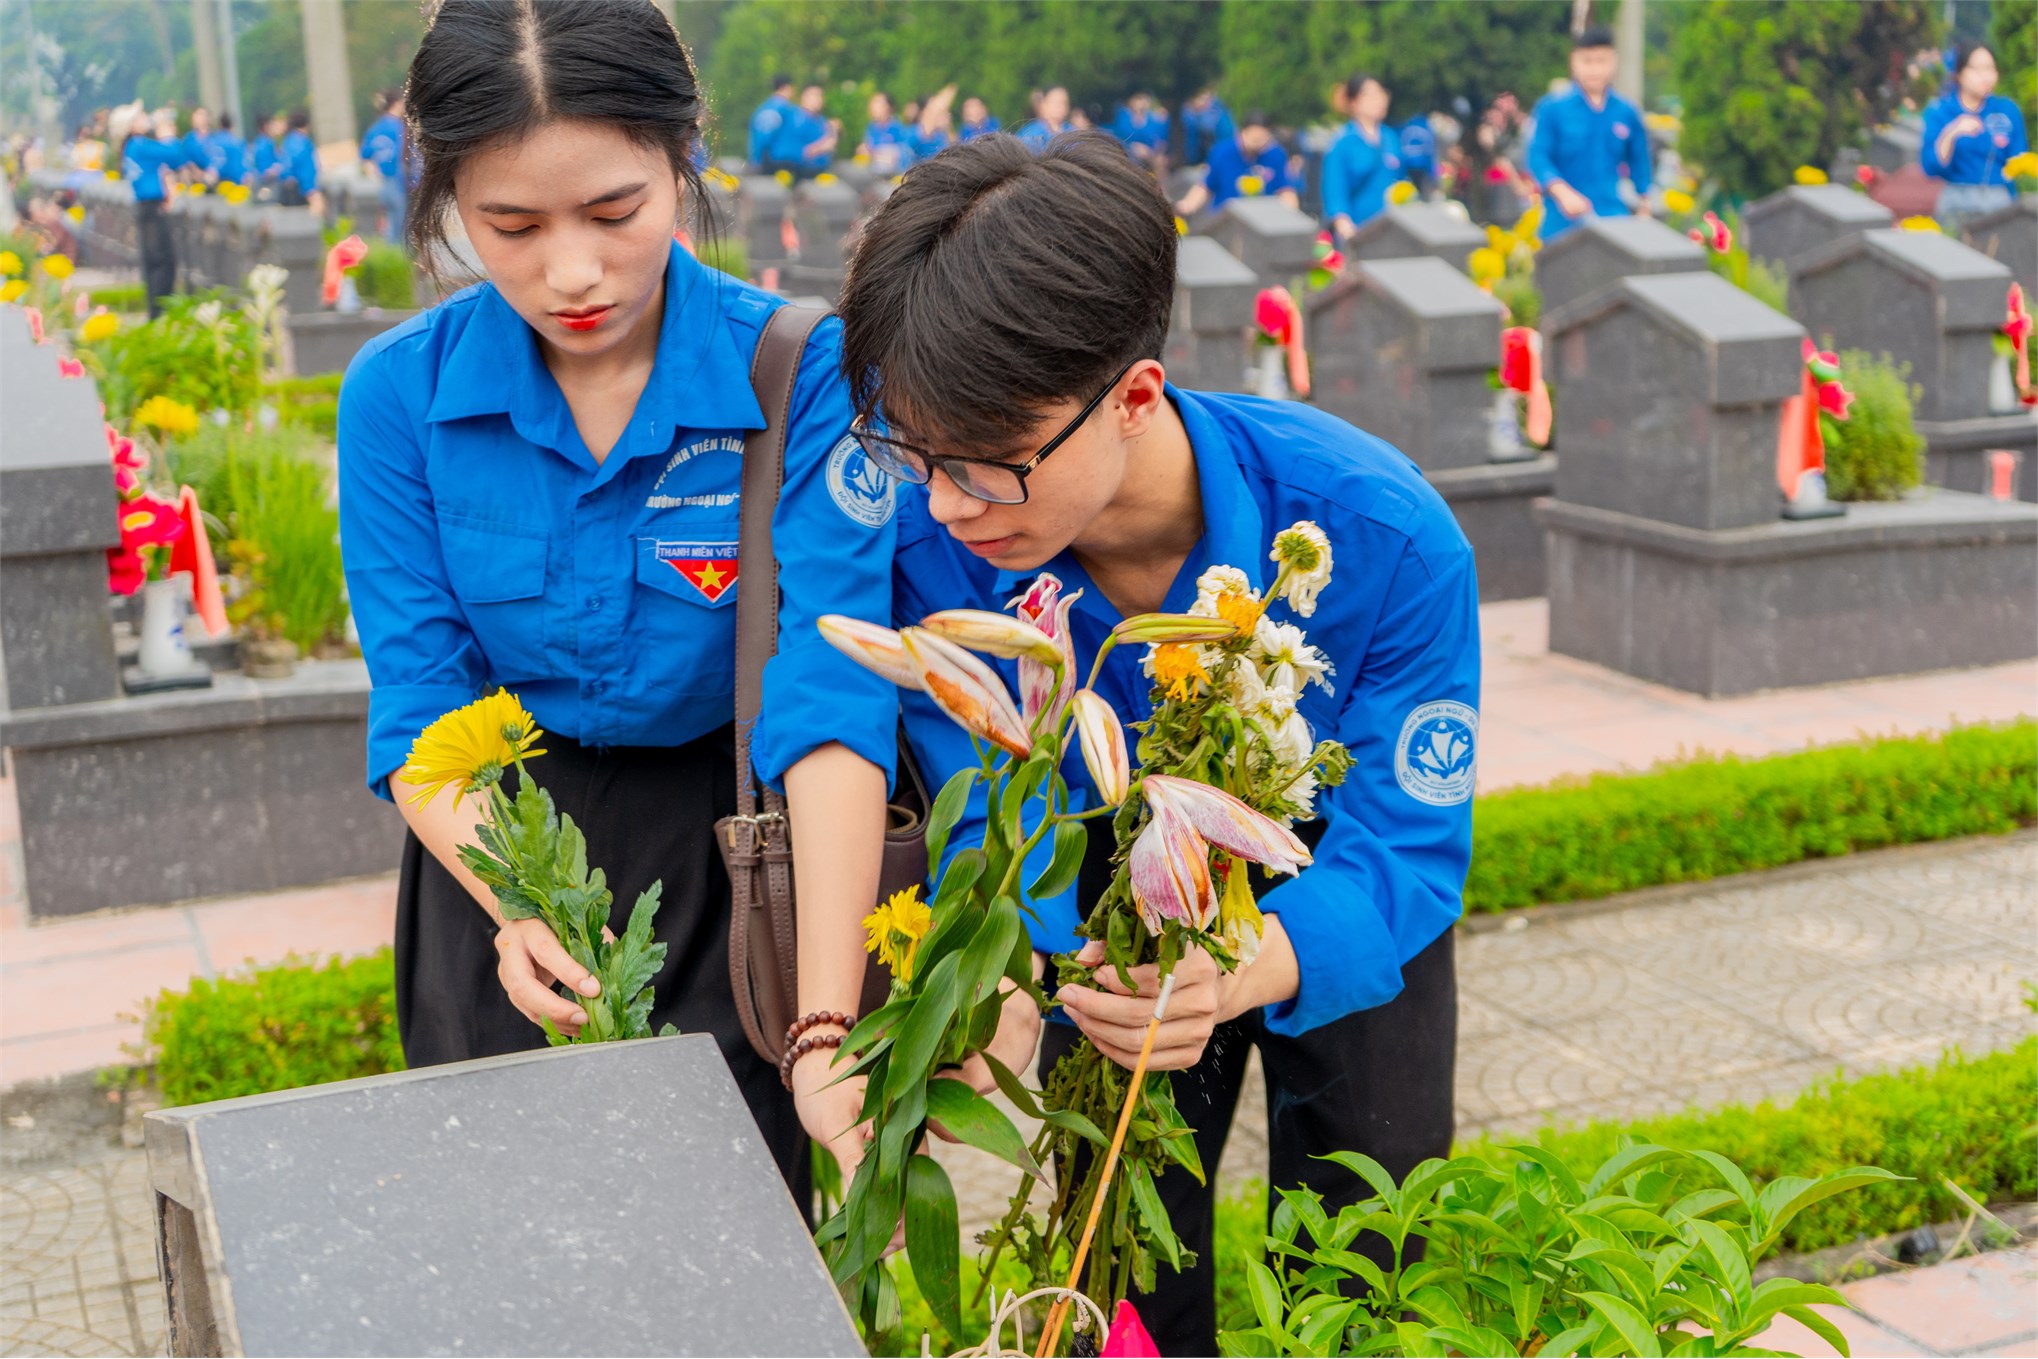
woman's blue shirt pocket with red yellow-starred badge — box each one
[632,520,740,697]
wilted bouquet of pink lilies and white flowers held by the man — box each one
[819,524,1349,1343]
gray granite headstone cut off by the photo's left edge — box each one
[0,308,120,709]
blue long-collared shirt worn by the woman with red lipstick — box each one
[338,244,899,802]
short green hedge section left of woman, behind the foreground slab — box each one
[137,949,404,1104]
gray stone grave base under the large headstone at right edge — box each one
[1537,491,2038,697]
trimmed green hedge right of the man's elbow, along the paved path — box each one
[1465,721,2038,913]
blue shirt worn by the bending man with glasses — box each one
[893,387,1480,1033]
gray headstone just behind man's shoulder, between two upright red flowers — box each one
[1308,257,1502,471]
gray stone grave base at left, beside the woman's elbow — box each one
[0,660,404,917]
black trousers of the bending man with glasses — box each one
[1039,876,1457,1355]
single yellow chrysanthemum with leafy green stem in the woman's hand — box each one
[404,691,675,1047]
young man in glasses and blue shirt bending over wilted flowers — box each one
[840,134,1480,1355]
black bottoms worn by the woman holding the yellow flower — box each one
[395,727,813,1210]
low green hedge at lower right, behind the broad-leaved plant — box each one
[1467,1037,2038,1251]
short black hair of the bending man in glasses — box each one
[836,132,1178,456]
